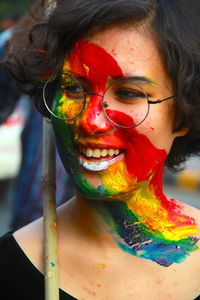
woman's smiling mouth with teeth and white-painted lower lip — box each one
[78,145,124,171]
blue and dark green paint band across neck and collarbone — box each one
[101,201,198,267]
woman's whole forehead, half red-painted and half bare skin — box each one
[64,26,171,89]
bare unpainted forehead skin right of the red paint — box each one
[89,27,165,77]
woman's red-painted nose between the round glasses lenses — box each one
[78,94,114,135]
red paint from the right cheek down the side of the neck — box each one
[121,128,196,226]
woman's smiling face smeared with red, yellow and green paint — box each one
[53,27,179,198]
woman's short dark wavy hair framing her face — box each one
[4,0,200,171]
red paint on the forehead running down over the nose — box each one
[69,40,123,134]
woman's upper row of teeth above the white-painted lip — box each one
[79,146,120,158]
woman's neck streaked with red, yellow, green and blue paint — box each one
[68,165,197,266]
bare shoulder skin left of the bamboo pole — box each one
[13,219,44,273]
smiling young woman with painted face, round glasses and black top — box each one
[1,0,200,300]
